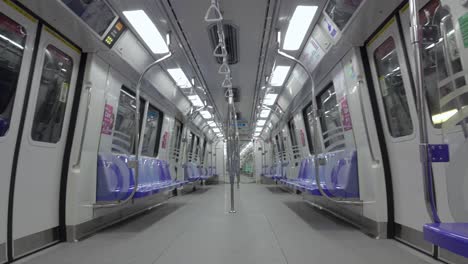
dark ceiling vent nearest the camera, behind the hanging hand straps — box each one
[208,24,239,65]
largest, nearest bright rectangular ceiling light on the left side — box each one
[123,10,169,54]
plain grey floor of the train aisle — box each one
[20,181,435,264]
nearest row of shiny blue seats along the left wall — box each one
[96,153,188,201]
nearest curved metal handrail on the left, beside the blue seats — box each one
[93,51,172,208]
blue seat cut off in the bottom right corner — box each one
[423,223,468,258]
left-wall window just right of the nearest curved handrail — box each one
[141,105,162,157]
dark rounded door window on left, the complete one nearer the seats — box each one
[31,45,73,143]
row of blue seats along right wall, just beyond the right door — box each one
[278,150,359,198]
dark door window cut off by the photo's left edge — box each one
[0,13,27,137]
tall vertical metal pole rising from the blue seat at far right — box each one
[409,0,440,223]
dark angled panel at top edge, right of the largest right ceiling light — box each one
[325,0,362,30]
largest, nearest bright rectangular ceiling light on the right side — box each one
[283,6,318,50]
